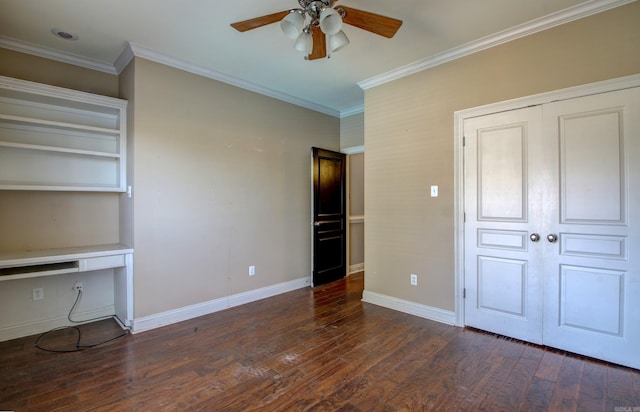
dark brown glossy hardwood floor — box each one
[0,274,640,412]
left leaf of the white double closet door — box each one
[464,107,542,343]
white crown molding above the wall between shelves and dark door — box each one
[116,43,340,117]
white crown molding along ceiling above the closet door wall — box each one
[358,0,636,90]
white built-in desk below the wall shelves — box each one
[0,244,133,326]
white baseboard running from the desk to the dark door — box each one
[132,277,311,333]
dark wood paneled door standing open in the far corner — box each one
[312,147,347,286]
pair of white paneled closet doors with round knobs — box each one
[464,88,640,368]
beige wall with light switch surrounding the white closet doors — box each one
[365,2,640,310]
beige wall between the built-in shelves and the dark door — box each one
[123,59,340,318]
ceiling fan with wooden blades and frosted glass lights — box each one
[231,0,402,60]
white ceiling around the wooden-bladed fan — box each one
[0,0,632,116]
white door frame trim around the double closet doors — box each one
[453,74,640,327]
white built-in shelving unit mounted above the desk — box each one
[0,76,127,192]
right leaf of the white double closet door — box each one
[542,88,640,368]
